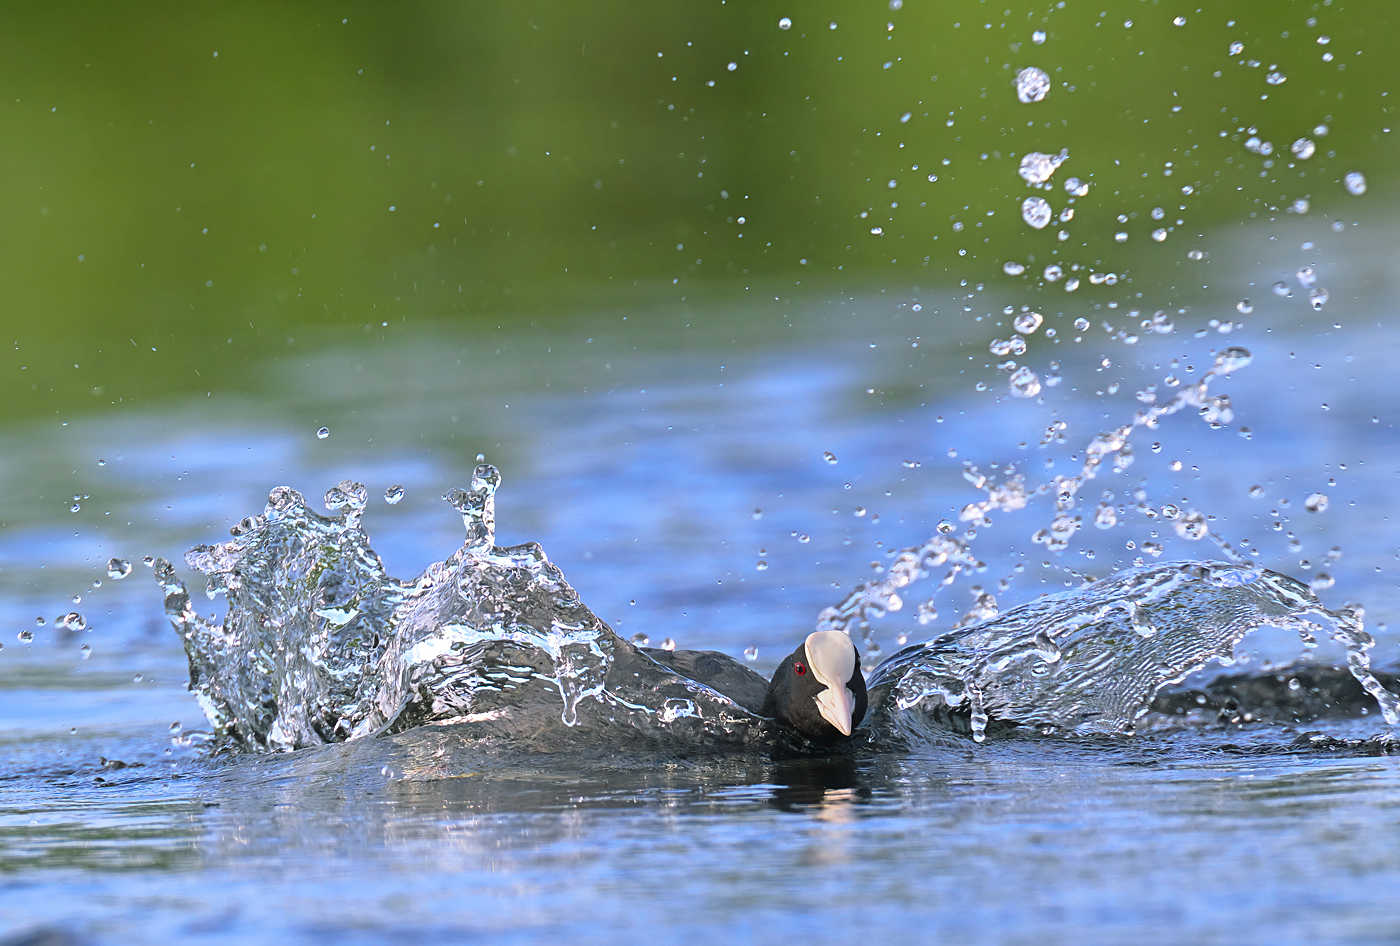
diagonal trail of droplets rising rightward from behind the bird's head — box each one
[816,347,1253,656]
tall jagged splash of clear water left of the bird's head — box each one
[165,465,770,751]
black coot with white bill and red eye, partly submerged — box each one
[643,631,867,746]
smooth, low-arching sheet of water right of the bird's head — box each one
[869,563,1400,740]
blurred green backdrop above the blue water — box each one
[0,0,1400,421]
